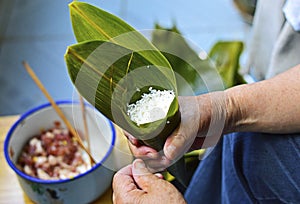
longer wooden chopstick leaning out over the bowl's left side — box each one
[22,61,96,165]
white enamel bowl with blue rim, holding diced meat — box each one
[4,101,116,203]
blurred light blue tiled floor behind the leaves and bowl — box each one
[0,0,255,116]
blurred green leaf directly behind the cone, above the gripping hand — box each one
[152,24,224,95]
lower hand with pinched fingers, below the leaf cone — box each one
[113,159,186,204]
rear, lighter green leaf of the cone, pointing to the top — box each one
[69,1,176,88]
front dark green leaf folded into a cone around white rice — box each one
[65,40,179,142]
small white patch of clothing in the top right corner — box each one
[283,0,300,31]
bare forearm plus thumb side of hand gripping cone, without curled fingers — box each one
[164,65,300,153]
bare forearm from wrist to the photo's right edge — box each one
[225,65,300,133]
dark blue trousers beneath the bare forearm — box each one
[185,133,300,204]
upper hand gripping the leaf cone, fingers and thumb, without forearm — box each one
[125,92,226,171]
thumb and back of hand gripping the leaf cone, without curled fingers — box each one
[163,91,226,160]
